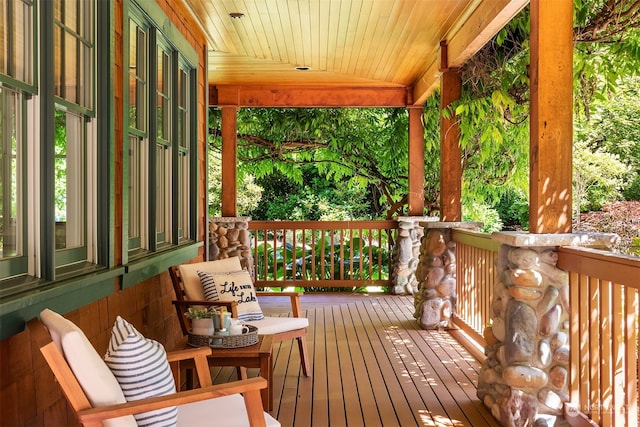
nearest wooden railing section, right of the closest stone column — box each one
[558,248,640,427]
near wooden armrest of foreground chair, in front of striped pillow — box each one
[78,377,267,425]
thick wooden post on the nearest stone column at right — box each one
[529,0,573,233]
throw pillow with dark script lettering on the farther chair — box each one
[198,270,264,322]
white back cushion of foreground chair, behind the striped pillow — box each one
[40,309,137,427]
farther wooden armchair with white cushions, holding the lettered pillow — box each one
[169,257,311,376]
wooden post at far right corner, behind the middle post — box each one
[408,106,424,216]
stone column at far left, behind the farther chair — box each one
[209,217,253,277]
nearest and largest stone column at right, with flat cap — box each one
[477,232,616,427]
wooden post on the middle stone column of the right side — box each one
[440,42,462,222]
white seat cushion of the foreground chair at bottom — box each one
[178,394,280,427]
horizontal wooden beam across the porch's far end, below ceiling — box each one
[209,86,412,107]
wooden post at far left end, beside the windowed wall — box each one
[221,107,238,217]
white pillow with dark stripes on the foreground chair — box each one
[104,316,178,427]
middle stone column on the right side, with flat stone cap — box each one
[413,221,482,329]
